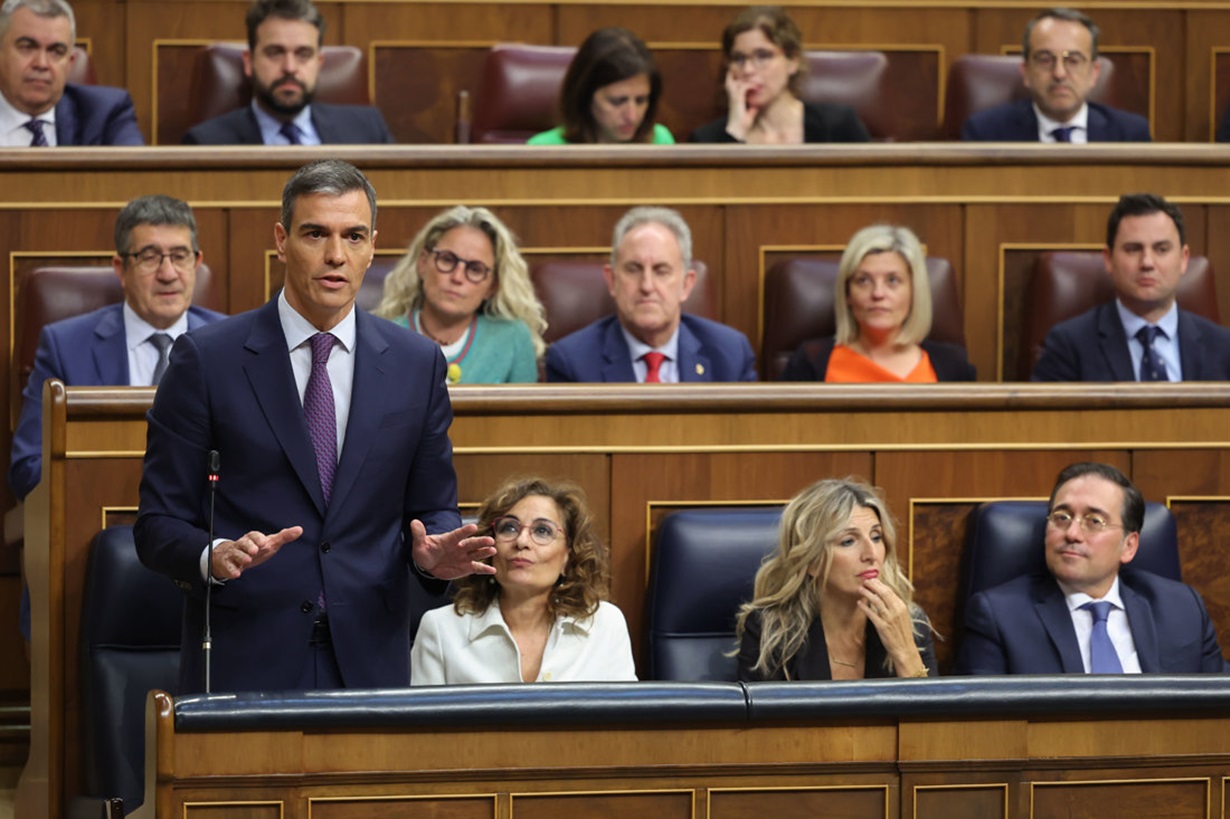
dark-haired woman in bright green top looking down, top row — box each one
[529,27,675,145]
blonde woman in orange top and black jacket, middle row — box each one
[781,225,977,384]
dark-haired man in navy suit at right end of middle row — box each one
[1030,193,1230,381]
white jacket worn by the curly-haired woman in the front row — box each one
[410,601,636,685]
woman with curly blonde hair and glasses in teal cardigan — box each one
[375,205,546,384]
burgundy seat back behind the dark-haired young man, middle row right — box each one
[1016,250,1221,381]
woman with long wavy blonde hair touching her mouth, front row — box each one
[736,480,938,681]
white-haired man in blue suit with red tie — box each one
[546,208,756,384]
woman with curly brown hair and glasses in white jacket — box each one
[411,478,636,685]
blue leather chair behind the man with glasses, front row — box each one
[962,501,1182,601]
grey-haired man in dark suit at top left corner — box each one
[0,0,145,148]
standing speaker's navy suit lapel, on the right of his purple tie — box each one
[330,307,391,509]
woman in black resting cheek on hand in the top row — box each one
[691,6,871,145]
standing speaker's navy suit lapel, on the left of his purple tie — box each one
[244,299,325,516]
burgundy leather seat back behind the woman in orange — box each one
[760,256,966,381]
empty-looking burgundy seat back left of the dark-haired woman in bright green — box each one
[470,43,577,144]
